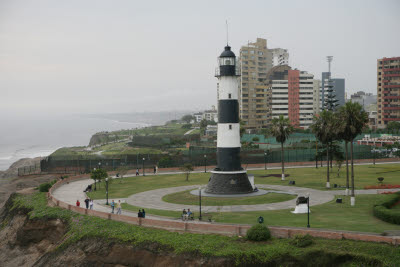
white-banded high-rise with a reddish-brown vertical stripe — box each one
[267,65,319,129]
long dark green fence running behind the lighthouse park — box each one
[33,144,393,173]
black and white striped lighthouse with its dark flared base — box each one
[205,45,253,194]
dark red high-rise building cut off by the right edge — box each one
[377,57,400,129]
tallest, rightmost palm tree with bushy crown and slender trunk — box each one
[339,101,368,206]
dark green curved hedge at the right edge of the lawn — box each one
[373,192,400,225]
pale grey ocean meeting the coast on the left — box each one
[0,115,147,170]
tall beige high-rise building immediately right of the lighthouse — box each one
[240,38,272,129]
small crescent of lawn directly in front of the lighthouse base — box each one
[163,190,296,206]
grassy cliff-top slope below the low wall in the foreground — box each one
[8,193,400,266]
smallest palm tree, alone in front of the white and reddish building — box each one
[270,115,294,181]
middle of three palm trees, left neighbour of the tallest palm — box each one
[311,110,339,188]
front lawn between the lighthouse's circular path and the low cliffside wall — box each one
[122,194,400,233]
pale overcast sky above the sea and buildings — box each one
[0,0,400,115]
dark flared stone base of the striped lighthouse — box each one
[205,171,254,194]
